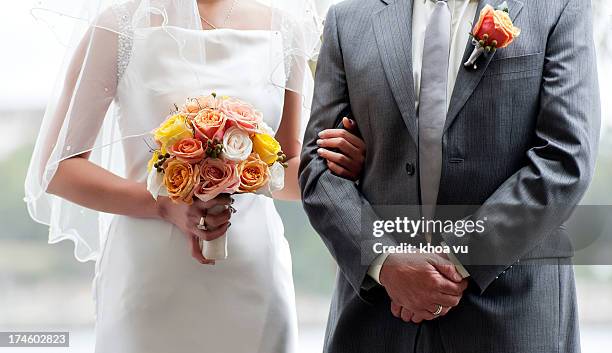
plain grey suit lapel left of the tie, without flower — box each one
[372,0,418,142]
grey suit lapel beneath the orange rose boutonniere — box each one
[444,0,523,132]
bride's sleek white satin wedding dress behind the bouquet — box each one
[94,27,297,353]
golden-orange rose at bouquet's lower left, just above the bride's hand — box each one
[164,159,200,205]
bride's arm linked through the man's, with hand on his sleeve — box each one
[274,90,365,201]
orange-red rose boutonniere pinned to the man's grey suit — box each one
[463,1,521,69]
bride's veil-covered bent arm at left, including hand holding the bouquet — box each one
[37,16,231,263]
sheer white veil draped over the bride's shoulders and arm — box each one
[25,0,322,262]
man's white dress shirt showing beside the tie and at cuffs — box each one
[368,0,478,284]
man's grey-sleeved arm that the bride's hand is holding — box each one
[300,7,395,295]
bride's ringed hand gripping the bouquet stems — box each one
[157,194,233,265]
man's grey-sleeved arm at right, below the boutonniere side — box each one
[443,0,600,291]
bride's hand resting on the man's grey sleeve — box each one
[317,117,366,181]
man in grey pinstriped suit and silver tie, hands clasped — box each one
[300,0,600,353]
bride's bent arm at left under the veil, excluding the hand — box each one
[40,20,166,218]
